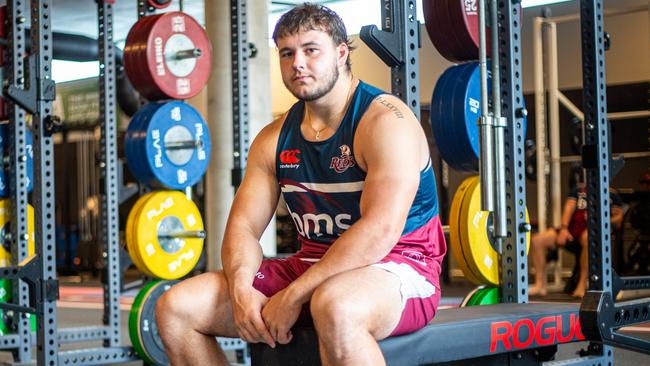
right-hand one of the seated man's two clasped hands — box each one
[262,289,302,344]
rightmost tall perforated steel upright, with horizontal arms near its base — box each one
[580,0,650,354]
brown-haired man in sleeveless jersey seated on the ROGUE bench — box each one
[156,4,446,365]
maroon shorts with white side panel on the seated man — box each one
[253,254,440,336]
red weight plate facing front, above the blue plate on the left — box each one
[142,11,212,100]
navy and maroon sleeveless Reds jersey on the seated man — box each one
[276,81,446,286]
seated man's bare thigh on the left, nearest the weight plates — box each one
[169,271,239,338]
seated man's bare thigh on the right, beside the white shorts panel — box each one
[312,267,402,340]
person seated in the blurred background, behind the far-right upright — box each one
[528,183,623,297]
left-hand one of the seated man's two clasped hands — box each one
[232,287,275,348]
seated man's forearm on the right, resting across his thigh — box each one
[289,219,401,304]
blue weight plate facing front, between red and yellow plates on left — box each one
[143,101,211,189]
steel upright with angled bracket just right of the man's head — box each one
[359,0,420,120]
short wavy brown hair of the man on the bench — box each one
[273,3,355,70]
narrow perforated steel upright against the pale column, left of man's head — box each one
[230,0,250,190]
